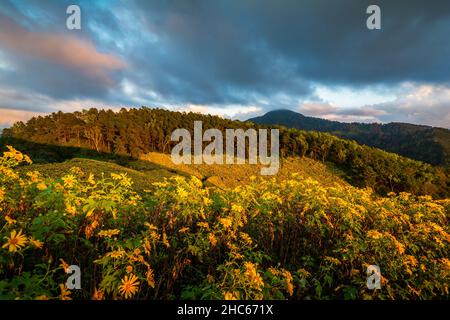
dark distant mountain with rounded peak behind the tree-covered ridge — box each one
[248,110,450,166]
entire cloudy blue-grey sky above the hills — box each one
[0,0,450,128]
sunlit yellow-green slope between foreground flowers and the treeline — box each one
[17,152,348,192]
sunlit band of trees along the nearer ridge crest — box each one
[3,108,450,197]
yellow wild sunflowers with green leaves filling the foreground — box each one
[0,147,450,299]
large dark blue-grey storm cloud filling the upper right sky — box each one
[131,0,450,87]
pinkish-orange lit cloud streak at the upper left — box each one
[0,17,126,85]
